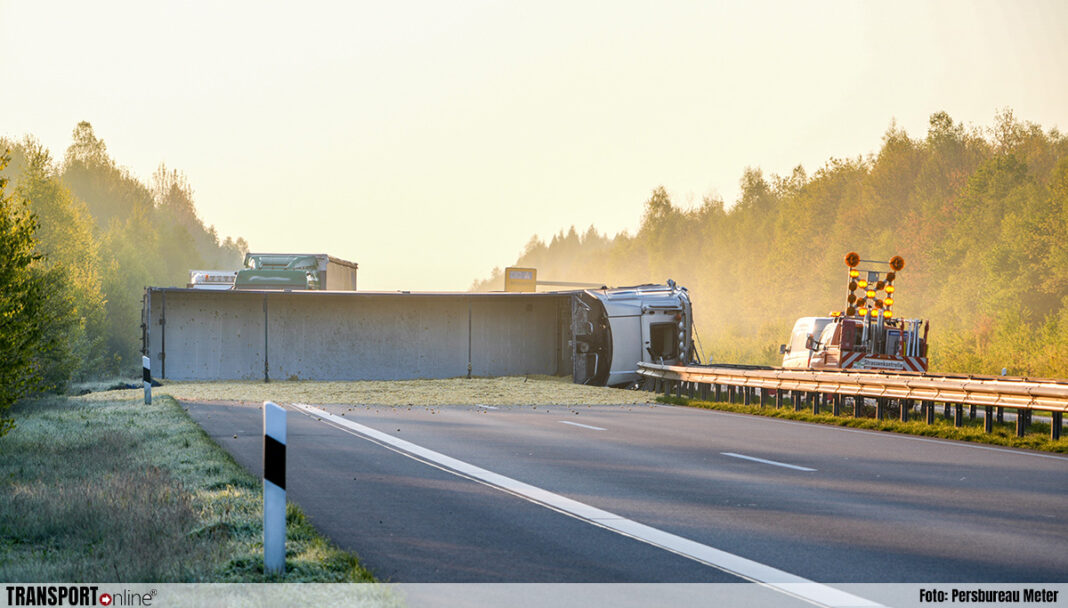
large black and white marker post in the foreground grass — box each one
[264,401,285,574]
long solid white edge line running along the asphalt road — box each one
[293,403,881,608]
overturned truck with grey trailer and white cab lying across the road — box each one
[142,282,693,385]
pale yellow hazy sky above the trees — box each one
[0,0,1068,290]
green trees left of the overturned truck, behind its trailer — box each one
[0,122,248,429]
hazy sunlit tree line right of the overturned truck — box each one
[472,110,1068,377]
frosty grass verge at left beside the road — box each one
[0,391,372,582]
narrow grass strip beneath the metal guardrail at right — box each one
[657,395,1068,453]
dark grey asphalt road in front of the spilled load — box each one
[185,403,1068,589]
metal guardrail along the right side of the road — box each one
[639,363,1068,439]
